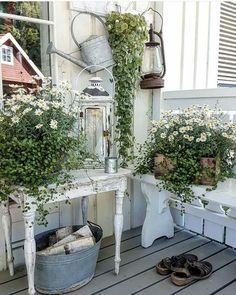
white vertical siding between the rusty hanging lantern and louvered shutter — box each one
[163,1,220,91]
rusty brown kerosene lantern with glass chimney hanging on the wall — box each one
[140,9,166,89]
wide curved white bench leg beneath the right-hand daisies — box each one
[141,182,174,248]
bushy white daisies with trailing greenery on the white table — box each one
[0,79,84,222]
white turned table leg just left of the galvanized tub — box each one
[23,212,36,295]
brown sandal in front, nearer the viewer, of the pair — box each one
[171,261,212,286]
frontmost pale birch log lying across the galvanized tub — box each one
[37,237,95,256]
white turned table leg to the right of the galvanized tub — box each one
[114,180,127,275]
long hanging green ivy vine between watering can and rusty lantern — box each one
[106,12,147,167]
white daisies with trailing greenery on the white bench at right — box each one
[136,106,236,202]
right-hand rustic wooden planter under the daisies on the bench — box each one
[200,157,219,185]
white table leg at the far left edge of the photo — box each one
[1,200,14,276]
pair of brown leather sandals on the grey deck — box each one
[156,254,212,286]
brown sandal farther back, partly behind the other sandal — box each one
[156,254,198,275]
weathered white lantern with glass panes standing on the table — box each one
[76,68,114,165]
